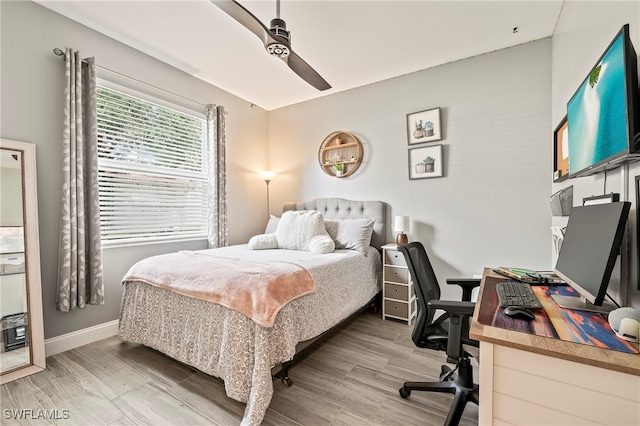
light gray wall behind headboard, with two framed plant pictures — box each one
[269,39,552,300]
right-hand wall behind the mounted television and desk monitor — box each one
[551,1,640,307]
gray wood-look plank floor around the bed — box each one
[0,312,478,426]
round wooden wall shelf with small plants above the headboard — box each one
[318,131,363,178]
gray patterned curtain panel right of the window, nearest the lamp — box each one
[205,105,227,248]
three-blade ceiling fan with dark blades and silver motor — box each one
[210,0,331,90]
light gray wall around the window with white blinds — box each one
[0,1,268,338]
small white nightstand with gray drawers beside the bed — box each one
[382,244,417,325]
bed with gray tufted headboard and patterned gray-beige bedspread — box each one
[118,198,386,425]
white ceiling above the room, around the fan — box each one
[35,0,563,110]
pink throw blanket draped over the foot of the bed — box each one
[122,251,315,327]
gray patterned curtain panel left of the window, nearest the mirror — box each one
[56,48,104,312]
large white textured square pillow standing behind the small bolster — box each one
[275,210,329,251]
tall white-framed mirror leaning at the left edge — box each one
[0,139,45,384]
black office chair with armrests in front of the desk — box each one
[398,242,480,425]
